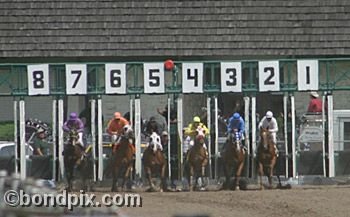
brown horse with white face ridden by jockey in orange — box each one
[111,125,134,192]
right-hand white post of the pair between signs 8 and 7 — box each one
[58,99,64,179]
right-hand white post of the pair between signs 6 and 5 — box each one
[135,96,142,177]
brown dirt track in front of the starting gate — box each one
[114,186,350,217]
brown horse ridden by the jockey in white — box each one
[257,128,277,189]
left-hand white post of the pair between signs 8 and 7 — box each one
[52,99,57,180]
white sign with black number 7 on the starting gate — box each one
[66,64,87,94]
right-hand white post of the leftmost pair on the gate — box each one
[19,99,27,180]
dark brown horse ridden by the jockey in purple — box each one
[63,129,89,192]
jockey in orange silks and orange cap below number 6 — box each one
[107,112,136,154]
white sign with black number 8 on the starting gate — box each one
[27,64,50,95]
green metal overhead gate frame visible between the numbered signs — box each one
[0,58,350,96]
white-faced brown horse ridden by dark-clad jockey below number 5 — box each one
[142,132,167,192]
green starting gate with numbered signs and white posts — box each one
[0,59,350,181]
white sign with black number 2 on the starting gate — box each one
[259,61,280,92]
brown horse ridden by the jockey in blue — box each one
[223,131,246,190]
